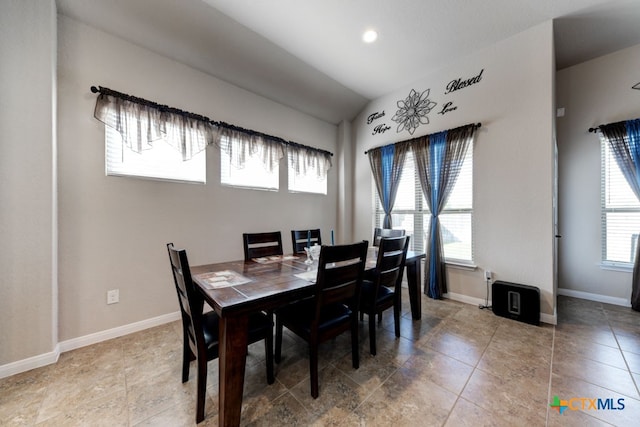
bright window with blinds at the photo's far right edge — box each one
[601,140,640,267]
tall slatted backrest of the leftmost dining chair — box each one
[167,243,206,359]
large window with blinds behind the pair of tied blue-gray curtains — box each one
[372,146,473,264]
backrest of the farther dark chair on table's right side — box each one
[373,236,409,288]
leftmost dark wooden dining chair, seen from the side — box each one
[167,243,275,423]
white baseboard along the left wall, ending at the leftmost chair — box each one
[0,311,180,378]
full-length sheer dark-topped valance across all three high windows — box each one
[91,86,333,172]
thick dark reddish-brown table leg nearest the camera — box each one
[218,316,249,426]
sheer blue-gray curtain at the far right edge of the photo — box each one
[600,119,640,311]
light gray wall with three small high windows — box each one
[58,16,339,341]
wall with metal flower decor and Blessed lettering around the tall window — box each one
[353,21,555,323]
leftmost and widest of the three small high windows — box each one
[105,121,207,184]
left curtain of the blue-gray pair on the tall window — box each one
[368,142,409,228]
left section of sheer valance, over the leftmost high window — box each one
[94,93,218,160]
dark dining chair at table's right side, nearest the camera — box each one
[275,240,369,399]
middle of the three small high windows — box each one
[220,138,280,191]
